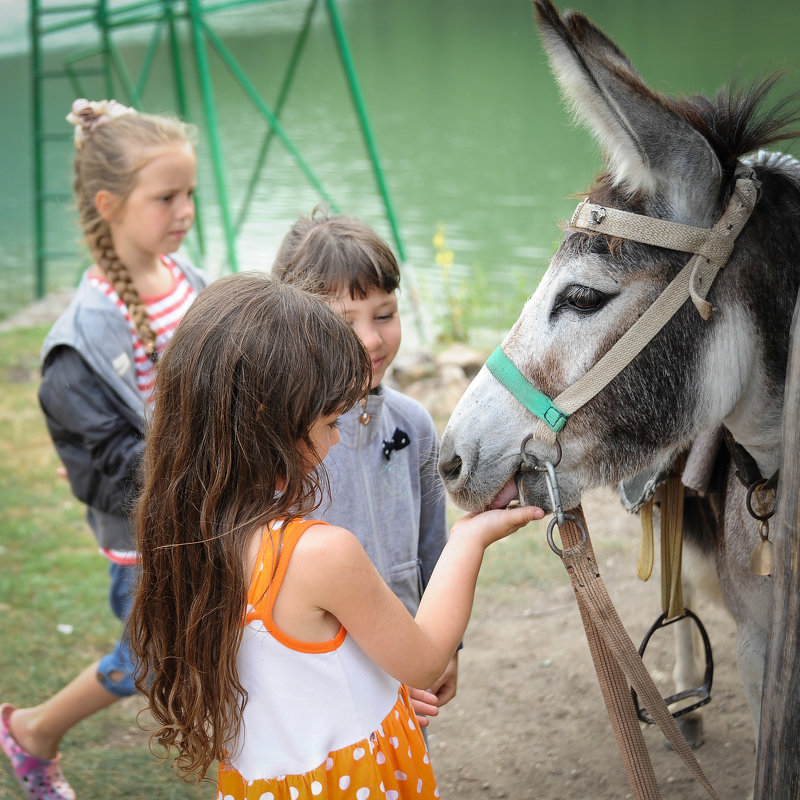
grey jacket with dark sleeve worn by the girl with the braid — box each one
[39,256,208,550]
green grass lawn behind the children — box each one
[0,328,563,800]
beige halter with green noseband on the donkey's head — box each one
[486,177,758,445]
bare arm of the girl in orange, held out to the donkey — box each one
[282,506,543,686]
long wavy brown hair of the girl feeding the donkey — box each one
[129,274,371,780]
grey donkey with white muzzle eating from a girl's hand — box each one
[439,0,800,752]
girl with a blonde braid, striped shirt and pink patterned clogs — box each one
[0,100,207,800]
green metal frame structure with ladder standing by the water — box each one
[29,0,405,298]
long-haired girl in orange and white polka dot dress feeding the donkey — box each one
[130,274,543,800]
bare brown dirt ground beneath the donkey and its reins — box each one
[429,492,754,800]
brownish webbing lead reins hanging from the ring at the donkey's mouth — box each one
[559,508,719,800]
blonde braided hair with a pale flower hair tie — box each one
[67,99,194,361]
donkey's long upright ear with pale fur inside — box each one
[534,0,722,221]
